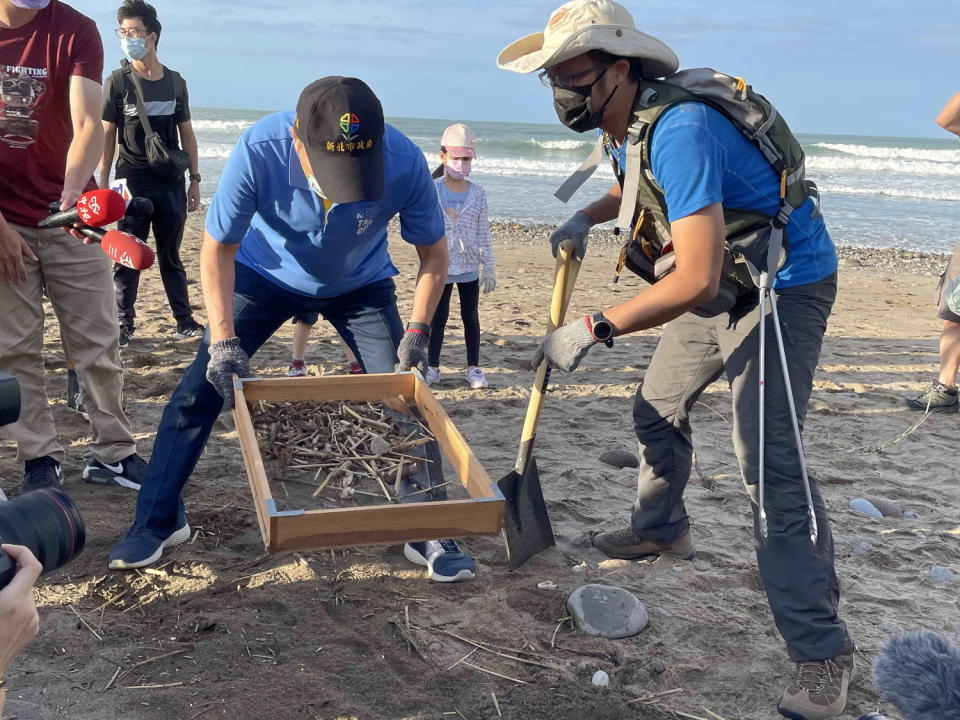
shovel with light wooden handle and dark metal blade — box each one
[497,241,580,570]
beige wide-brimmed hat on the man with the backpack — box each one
[497,0,680,77]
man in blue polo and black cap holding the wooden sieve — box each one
[110,77,475,582]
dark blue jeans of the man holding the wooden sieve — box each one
[134,263,403,533]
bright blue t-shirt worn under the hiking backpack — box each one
[619,102,837,288]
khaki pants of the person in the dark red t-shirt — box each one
[0,225,136,463]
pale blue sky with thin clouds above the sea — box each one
[68,0,960,137]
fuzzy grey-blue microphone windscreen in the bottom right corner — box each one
[873,630,960,720]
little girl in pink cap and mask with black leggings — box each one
[426,123,497,388]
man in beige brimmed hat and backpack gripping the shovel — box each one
[498,0,853,720]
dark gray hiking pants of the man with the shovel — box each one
[633,275,852,661]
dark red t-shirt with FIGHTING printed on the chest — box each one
[0,0,103,227]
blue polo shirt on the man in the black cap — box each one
[206,112,444,297]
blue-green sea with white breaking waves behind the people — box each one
[193,108,960,252]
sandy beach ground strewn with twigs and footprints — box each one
[0,215,960,720]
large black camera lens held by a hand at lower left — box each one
[0,488,87,588]
